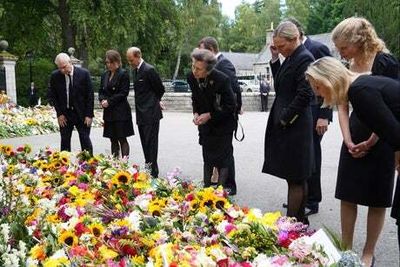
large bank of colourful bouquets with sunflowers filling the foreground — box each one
[0,144,354,267]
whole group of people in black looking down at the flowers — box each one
[48,17,400,266]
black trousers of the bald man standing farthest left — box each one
[60,109,93,155]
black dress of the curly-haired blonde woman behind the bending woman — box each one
[335,53,400,207]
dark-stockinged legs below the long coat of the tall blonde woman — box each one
[286,180,308,223]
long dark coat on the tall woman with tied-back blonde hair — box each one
[262,45,314,180]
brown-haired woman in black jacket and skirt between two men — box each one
[99,50,134,157]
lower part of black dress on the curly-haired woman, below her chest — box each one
[335,112,394,208]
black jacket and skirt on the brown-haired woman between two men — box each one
[99,69,134,138]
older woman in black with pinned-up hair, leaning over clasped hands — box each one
[187,48,236,194]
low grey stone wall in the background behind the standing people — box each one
[95,91,275,112]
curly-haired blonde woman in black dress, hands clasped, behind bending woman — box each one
[332,17,399,266]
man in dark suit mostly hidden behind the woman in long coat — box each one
[288,18,332,215]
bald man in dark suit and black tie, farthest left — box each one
[47,53,94,154]
